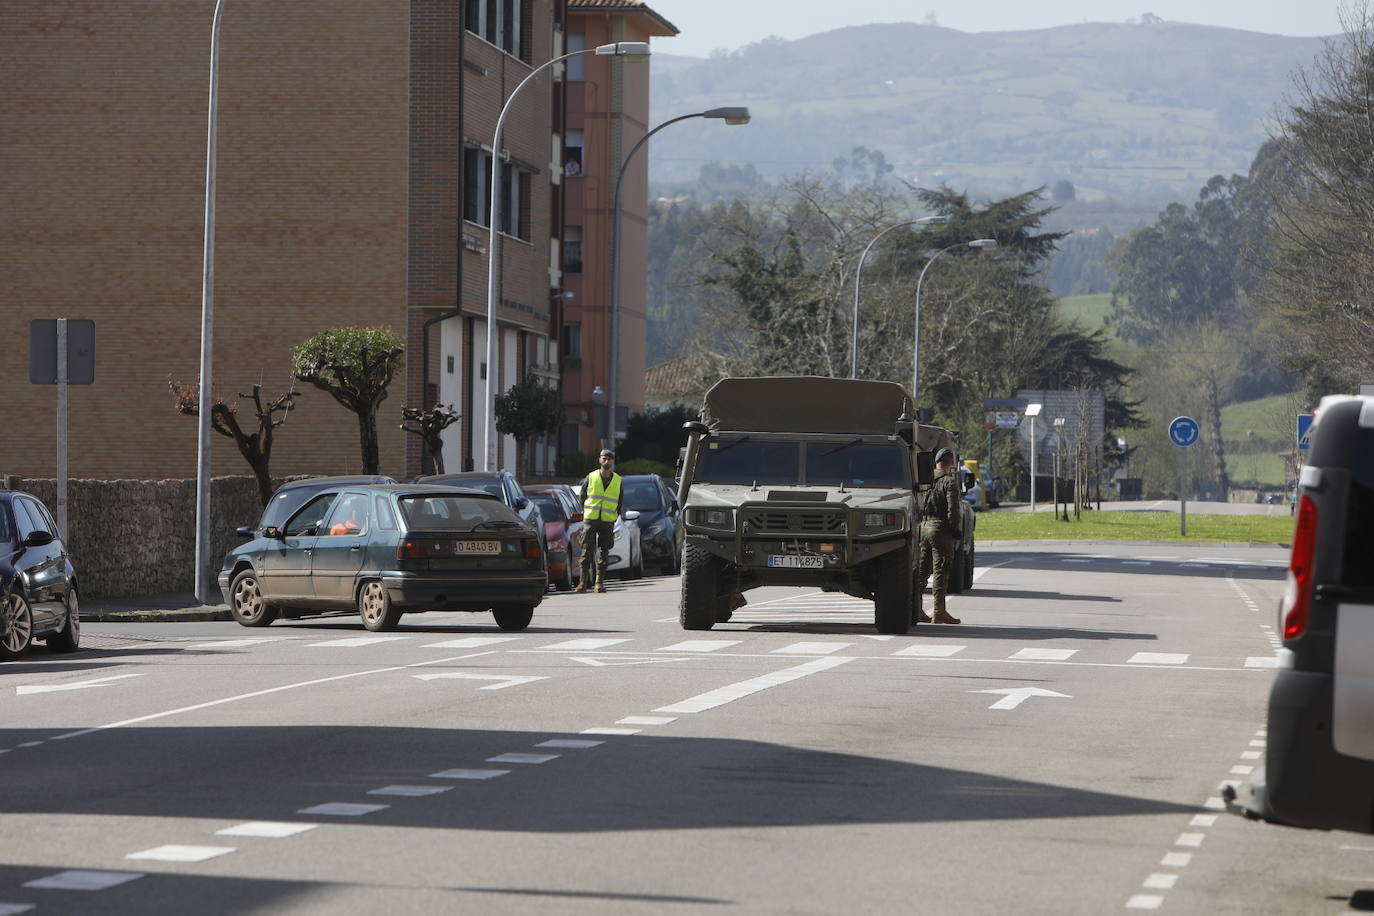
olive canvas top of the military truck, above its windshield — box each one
[701,376,911,435]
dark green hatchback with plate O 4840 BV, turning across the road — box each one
[220,483,548,630]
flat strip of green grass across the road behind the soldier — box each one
[976,507,1293,544]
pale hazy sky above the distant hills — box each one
[647,0,1349,56]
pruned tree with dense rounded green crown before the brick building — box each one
[291,327,405,474]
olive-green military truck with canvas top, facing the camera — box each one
[679,376,933,633]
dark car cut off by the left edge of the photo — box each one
[0,490,81,661]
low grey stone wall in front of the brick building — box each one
[8,477,262,603]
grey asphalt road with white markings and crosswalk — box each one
[0,545,1357,915]
